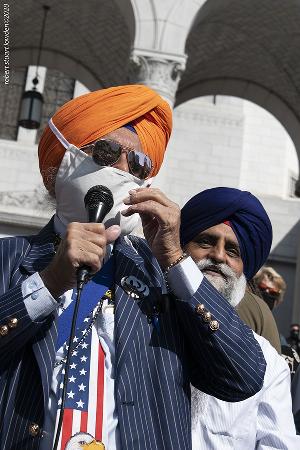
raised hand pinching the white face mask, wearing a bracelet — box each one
[122,188,182,269]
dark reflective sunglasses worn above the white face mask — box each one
[80,139,152,180]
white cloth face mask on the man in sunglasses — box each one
[55,145,149,235]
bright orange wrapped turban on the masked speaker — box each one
[38,84,172,187]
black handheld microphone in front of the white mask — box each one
[77,185,114,288]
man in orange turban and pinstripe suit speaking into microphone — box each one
[0,85,265,450]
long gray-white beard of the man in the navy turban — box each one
[191,258,247,429]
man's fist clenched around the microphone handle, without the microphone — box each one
[40,222,121,298]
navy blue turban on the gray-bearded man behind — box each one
[180,187,272,280]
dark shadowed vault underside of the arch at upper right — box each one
[176,0,300,195]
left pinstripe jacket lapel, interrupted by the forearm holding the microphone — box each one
[20,218,57,408]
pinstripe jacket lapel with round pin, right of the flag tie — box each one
[114,238,161,371]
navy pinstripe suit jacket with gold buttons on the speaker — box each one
[0,220,265,450]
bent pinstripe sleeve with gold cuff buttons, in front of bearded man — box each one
[175,278,266,402]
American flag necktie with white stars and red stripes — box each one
[55,258,113,450]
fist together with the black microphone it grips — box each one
[40,186,121,298]
